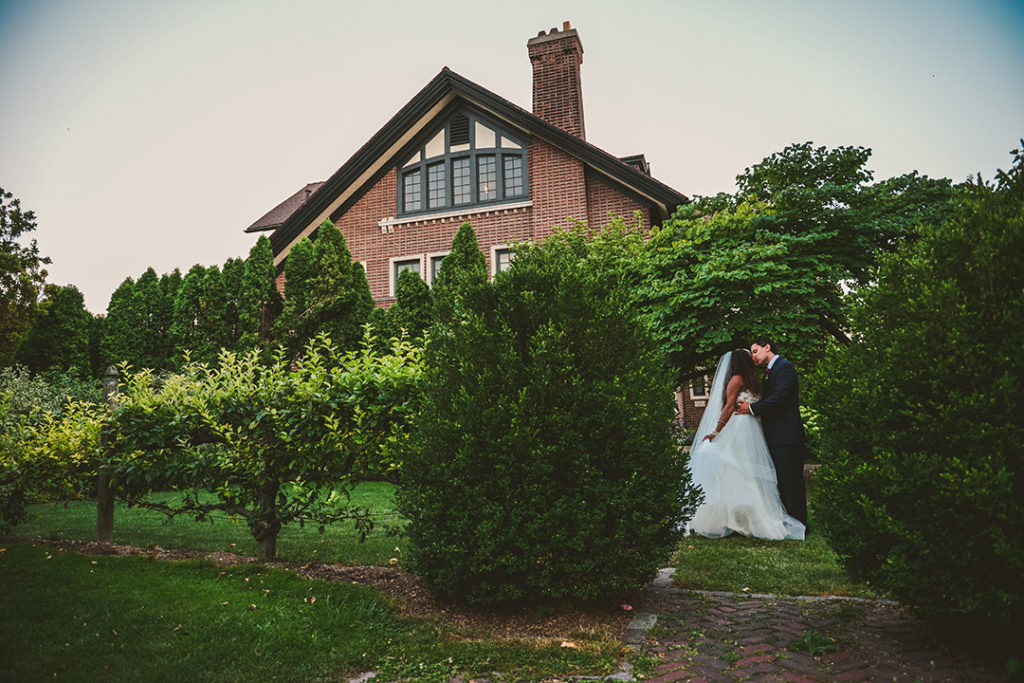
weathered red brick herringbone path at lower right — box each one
[645,577,1009,683]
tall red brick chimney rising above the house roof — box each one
[526,22,587,139]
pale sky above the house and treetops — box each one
[0,0,1024,313]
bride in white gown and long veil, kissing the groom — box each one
[686,349,805,541]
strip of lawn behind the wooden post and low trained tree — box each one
[11,481,400,565]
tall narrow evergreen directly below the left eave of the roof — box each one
[239,234,283,348]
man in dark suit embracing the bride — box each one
[736,337,807,526]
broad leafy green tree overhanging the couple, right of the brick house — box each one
[639,142,954,378]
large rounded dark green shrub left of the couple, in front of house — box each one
[398,231,693,604]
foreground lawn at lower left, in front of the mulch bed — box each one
[0,544,623,681]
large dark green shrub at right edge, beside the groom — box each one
[809,149,1024,656]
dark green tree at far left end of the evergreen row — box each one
[17,285,92,376]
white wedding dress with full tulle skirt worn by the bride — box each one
[686,359,805,541]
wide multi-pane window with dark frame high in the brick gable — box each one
[398,113,529,216]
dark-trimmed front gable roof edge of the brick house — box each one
[270,67,689,263]
